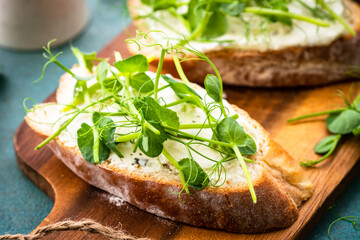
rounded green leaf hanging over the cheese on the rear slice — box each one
[203,10,228,38]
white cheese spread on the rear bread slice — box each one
[139,0,346,52]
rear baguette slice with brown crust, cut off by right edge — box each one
[128,0,360,87]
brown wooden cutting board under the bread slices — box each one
[14,27,360,240]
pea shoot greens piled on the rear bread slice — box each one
[136,0,355,43]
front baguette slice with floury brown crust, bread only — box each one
[25,69,313,233]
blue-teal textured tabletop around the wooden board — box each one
[0,0,360,239]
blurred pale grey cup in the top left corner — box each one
[0,0,89,50]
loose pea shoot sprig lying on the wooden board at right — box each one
[288,87,360,167]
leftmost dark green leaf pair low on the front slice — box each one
[77,123,110,163]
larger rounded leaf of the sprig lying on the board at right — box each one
[326,109,360,134]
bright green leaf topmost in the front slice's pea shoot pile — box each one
[114,54,149,73]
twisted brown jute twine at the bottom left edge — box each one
[0,219,150,240]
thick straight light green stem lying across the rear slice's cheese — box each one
[244,7,330,27]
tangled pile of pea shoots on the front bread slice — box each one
[31,35,257,202]
